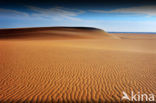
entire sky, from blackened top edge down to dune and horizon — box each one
[0,0,156,32]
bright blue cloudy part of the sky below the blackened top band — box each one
[0,5,156,32]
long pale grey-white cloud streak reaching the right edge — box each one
[89,5,156,16]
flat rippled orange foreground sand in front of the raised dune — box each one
[0,40,156,103]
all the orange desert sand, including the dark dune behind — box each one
[0,27,156,103]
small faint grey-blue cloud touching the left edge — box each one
[0,8,29,17]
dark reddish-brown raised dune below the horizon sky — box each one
[0,27,108,39]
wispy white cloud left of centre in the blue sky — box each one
[28,6,84,21]
